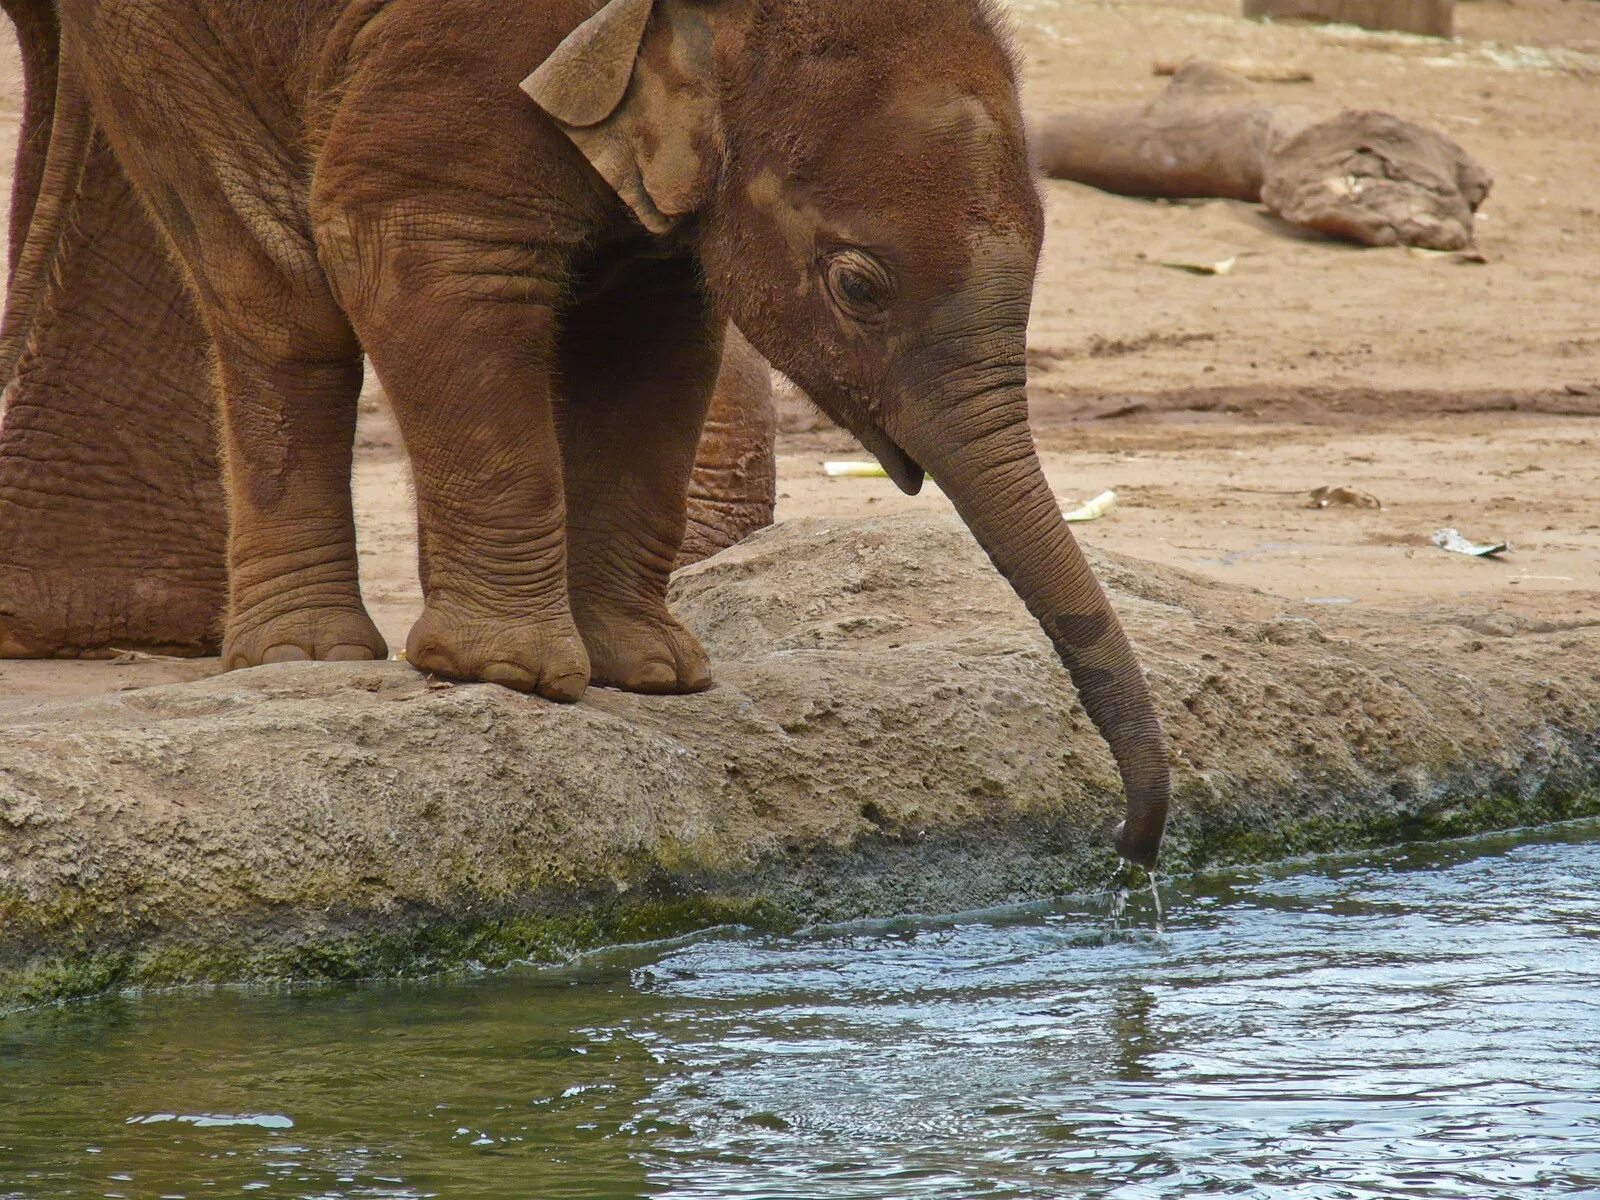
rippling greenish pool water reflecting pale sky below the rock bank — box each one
[0,822,1600,1200]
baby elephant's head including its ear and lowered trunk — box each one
[525,0,1171,866]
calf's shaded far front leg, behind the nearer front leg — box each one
[560,261,723,693]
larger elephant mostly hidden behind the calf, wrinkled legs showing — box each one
[0,0,776,658]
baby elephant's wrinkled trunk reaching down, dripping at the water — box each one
[902,384,1171,869]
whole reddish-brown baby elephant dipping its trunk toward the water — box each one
[8,0,1171,864]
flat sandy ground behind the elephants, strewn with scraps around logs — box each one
[0,0,1600,696]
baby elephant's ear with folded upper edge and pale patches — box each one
[522,0,722,234]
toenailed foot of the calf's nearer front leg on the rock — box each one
[406,600,589,704]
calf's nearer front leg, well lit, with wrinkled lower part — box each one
[337,233,589,702]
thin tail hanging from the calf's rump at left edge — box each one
[0,42,94,395]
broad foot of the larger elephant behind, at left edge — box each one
[0,568,226,659]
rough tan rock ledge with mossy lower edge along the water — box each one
[0,515,1600,1011]
